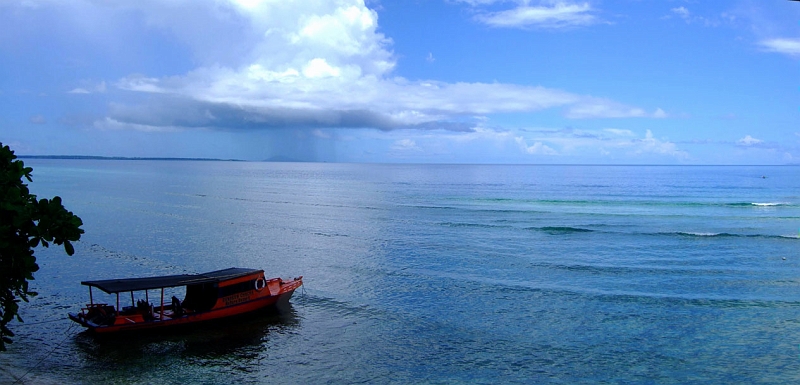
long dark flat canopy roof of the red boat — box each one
[81,267,262,294]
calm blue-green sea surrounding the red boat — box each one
[0,159,800,384]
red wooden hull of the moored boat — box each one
[69,272,303,335]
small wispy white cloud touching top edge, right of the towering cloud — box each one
[475,1,598,28]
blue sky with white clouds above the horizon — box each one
[0,0,800,165]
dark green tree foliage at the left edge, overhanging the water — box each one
[0,143,83,351]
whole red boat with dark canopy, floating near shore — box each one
[69,267,303,334]
